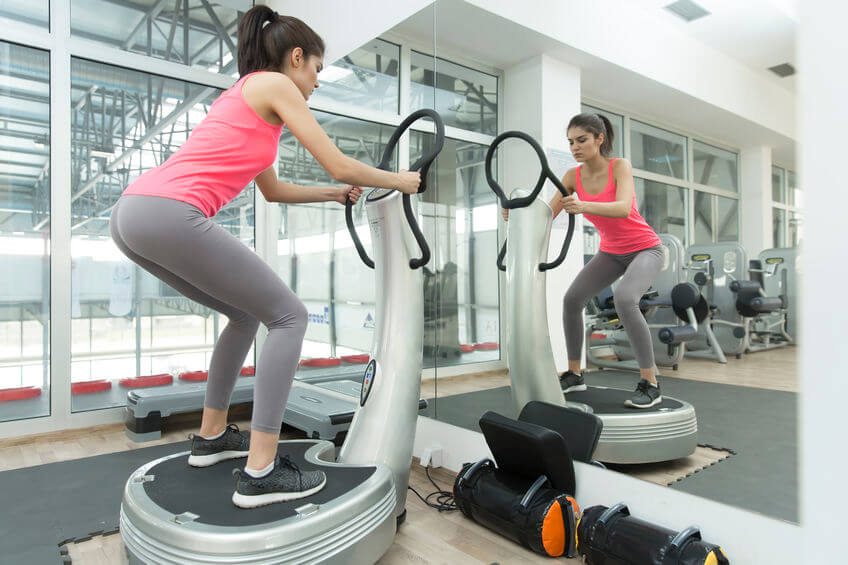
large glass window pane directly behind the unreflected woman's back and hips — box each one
[70,59,245,411]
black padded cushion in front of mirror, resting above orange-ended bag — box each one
[480,411,575,494]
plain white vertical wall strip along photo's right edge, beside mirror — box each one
[797,0,848,563]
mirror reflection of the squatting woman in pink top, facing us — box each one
[504,114,664,408]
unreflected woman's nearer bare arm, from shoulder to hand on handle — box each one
[253,73,421,194]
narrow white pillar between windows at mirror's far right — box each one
[739,145,772,254]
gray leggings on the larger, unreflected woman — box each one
[110,195,307,434]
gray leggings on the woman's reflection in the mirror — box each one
[562,245,664,369]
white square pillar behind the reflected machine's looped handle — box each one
[499,54,583,371]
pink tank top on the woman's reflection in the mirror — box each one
[576,159,661,255]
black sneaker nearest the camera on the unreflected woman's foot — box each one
[233,455,327,508]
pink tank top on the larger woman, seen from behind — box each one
[124,73,283,217]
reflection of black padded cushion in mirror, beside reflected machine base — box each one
[518,400,604,463]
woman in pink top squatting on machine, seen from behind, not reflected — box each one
[111,6,421,507]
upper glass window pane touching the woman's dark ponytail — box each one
[71,0,248,75]
